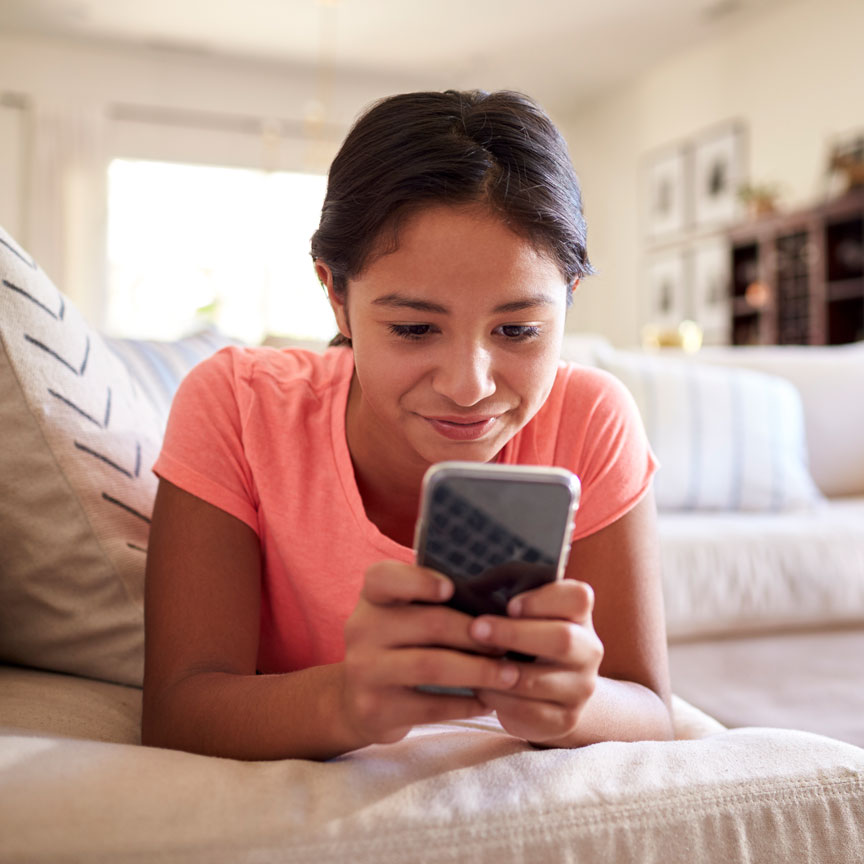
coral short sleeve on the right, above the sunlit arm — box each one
[556,367,657,540]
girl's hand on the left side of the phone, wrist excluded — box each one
[342,561,519,744]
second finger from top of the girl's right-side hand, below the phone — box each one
[469,615,603,670]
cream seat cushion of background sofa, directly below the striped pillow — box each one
[659,496,864,636]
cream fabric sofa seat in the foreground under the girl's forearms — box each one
[0,669,864,864]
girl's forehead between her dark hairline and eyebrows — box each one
[356,204,566,291]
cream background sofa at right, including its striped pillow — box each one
[593,343,864,746]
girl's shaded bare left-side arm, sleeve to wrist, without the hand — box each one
[141,480,361,759]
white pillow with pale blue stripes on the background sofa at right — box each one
[600,351,822,512]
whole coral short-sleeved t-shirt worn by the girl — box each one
[153,348,655,673]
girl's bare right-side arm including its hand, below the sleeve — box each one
[472,492,673,747]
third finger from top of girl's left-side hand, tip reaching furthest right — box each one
[365,648,519,690]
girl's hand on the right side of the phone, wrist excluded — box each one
[469,579,603,744]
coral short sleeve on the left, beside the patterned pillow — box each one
[153,348,258,532]
